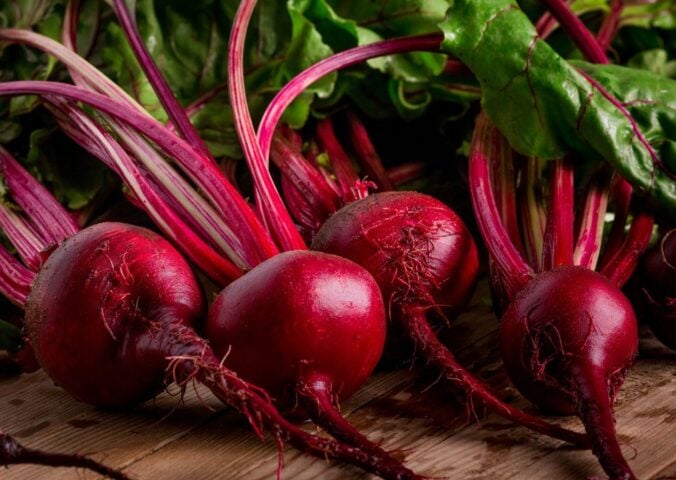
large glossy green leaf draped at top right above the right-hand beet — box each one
[441,0,676,212]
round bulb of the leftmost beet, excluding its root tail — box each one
[26,223,205,407]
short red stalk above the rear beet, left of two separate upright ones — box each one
[316,118,368,203]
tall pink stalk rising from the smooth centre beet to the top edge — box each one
[228,0,307,250]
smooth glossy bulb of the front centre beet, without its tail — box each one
[206,251,385,407]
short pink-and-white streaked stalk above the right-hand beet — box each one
[573,169,610,270]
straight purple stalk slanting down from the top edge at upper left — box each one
[113,0,215,161]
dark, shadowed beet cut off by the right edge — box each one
[635,229,676,350]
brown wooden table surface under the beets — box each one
[0,285,676,480]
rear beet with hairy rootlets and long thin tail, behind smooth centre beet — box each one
[312,192,586,444]
